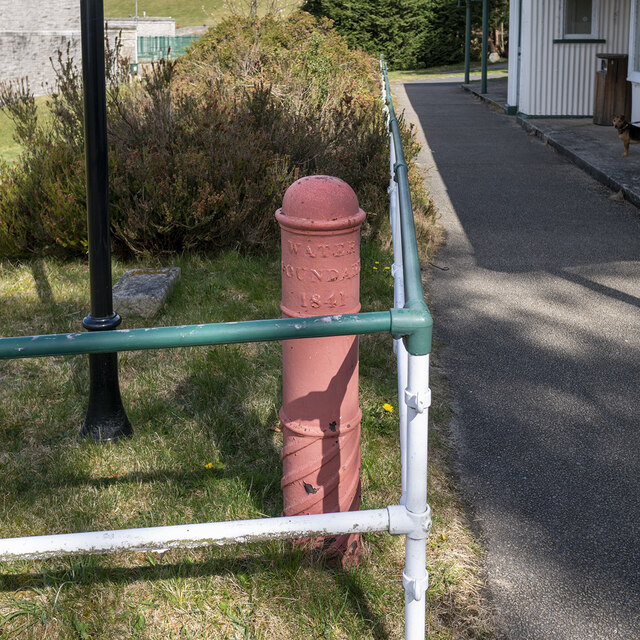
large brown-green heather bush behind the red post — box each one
[0,13,436,256]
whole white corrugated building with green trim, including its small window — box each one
[507,0,640,120]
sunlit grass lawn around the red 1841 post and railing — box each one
[0,243,487,640]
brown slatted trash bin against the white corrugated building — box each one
[593,53,631,125]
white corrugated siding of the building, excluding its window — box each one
[519,0,631,116]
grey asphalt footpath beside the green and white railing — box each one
[394,81,640,640]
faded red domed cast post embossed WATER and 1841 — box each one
[276,176,365,564]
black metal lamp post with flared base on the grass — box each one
[80,0,132,441]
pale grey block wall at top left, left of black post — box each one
[0,0,81,95]
